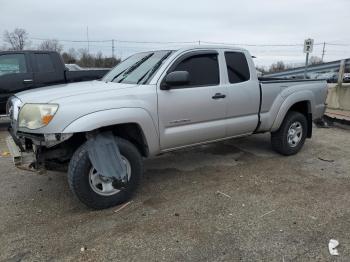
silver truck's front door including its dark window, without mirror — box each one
[157,50,227,151]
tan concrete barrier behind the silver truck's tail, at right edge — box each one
[326,83,350,111]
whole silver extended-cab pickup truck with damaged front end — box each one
[8,46,327,209]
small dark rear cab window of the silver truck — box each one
[225,52,250,84]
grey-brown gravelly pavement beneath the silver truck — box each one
[0,128,350,261]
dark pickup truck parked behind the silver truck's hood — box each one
[0,51,109,115]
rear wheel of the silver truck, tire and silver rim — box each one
[271,111,307,156]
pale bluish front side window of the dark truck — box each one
[0,54,27,76]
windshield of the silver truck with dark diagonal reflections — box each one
[102,50,173,84]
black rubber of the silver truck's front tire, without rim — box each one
[68,138,143,209]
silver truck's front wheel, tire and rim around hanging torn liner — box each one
[68,138,143,209]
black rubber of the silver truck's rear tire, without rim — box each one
[271,111,307,156]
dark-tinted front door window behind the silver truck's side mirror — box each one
[172,54,220,87]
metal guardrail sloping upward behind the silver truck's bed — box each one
[264,58,350,77]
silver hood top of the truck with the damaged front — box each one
[16,81,135,103]
